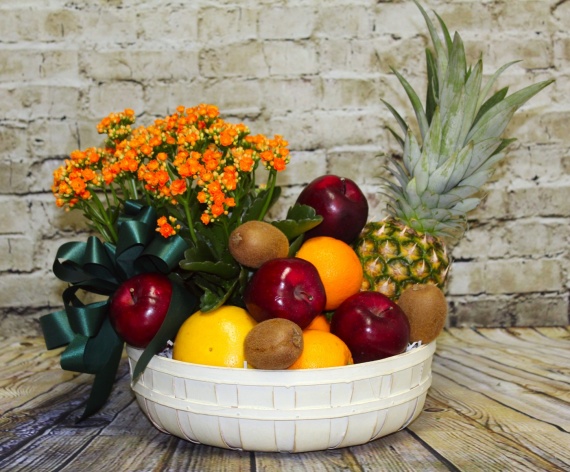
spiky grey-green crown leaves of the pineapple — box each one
[383,0,552,239]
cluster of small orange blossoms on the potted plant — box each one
[52,104,289,242]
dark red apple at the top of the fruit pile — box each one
[297,175,368,244]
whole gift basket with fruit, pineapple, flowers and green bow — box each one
[36,2,551,452]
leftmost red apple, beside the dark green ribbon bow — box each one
[109,272,172,348]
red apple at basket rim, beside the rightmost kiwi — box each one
[331,291,410,364]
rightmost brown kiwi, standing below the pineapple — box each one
[398,284,447,344]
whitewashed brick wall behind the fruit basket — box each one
[0,0,570,332]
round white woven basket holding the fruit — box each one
[127,341,435,452]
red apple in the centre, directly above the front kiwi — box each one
[244,257,326,329]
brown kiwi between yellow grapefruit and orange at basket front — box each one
[244,318,303,370]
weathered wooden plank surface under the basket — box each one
[0,327,570,472]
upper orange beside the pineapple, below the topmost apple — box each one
[297,236,363,310]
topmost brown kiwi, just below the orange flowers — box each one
[229,221,289,269]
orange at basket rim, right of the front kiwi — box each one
[289,329,353,369]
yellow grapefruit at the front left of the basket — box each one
[172,305,257,367]
